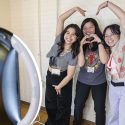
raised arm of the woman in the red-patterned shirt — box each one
[96,1,125,29]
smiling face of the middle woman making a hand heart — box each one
[82,22,95,35]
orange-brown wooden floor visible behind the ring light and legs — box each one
[21,103,95,125]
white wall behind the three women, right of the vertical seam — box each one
[41,0,125,121]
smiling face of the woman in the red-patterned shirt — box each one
[104,28,120,47]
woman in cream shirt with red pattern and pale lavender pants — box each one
[97,1,125,125]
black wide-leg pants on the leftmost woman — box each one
[45,71,73,125]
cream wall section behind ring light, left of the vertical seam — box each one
[10,0,40,102]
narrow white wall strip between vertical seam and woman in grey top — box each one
[40,0,57,106]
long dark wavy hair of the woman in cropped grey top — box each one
[58,24,82,58]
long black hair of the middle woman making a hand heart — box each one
[81,18,104,51]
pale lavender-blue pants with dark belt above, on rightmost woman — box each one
[108,84,125,125]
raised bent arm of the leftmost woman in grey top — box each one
[56,7,86,36]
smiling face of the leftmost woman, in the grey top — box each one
[64,27,77,45]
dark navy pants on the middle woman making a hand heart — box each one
[74,81,107,125]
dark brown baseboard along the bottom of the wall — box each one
[21,101,95,125]
